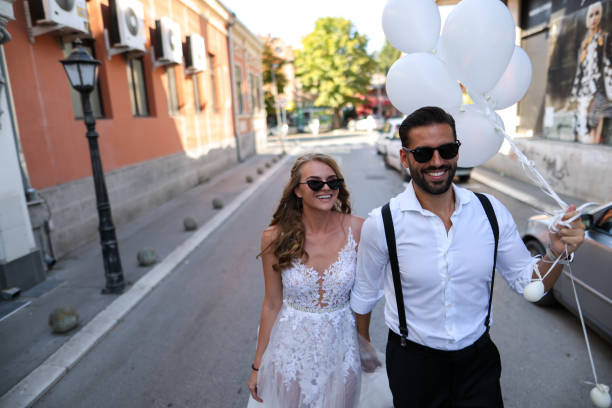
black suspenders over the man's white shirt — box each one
[381,193,499,347]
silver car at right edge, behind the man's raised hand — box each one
[523,202,612,343]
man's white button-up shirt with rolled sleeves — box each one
[351,183,538,350]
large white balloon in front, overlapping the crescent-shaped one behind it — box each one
[441,0,515,92]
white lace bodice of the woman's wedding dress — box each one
[282,227,357,310]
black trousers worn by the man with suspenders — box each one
[386,330,504,408]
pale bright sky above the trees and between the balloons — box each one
[221,0,452,53]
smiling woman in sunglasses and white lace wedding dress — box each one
[248,154,390,408]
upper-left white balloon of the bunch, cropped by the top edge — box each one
[382,0,441,53]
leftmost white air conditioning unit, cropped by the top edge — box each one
[29,0,89,33]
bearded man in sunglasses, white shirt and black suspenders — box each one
[351,107,585,408]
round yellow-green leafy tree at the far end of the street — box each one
[294,17,376,128]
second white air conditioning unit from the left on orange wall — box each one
[109,0,147,52]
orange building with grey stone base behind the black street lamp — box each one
[0,0,266,288]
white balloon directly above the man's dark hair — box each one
[386,52,461,115]
